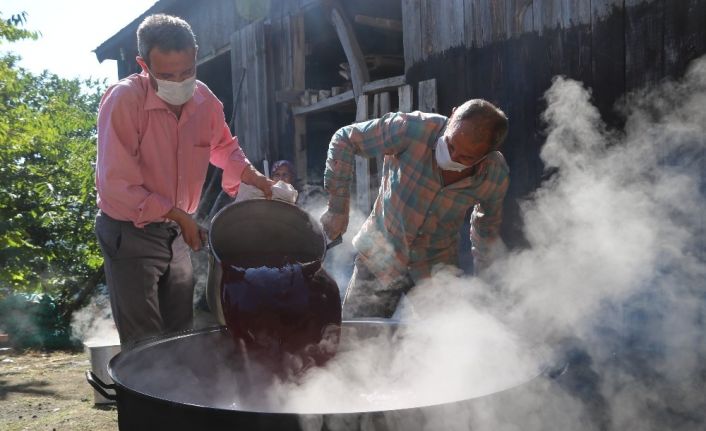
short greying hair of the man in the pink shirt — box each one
[137,14,197,65]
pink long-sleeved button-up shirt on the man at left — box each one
[96,74,250,227]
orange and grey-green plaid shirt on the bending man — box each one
[324,112,509,284]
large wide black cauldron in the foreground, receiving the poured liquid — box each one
[87,320,540,431]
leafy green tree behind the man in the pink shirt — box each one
[0,13,105,344]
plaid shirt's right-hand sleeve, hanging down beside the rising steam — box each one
[470,151,510,266]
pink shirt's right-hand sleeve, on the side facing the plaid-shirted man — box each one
[204,102,250,197]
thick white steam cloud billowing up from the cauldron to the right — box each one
[280,54,706,430]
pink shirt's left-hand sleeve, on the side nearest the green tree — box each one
[96,85,173,227]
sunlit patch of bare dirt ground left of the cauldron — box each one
[0,348,118,431]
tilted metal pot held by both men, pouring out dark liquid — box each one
[206,199,333,325]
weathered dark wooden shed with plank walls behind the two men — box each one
[96,0,706,245]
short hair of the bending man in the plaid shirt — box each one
[448,99,508,150]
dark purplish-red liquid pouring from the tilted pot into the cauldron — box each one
[221,255,341,372]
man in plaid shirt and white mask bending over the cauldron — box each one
[321,99,509,317]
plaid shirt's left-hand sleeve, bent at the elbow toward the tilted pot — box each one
[324,112,408,213]
